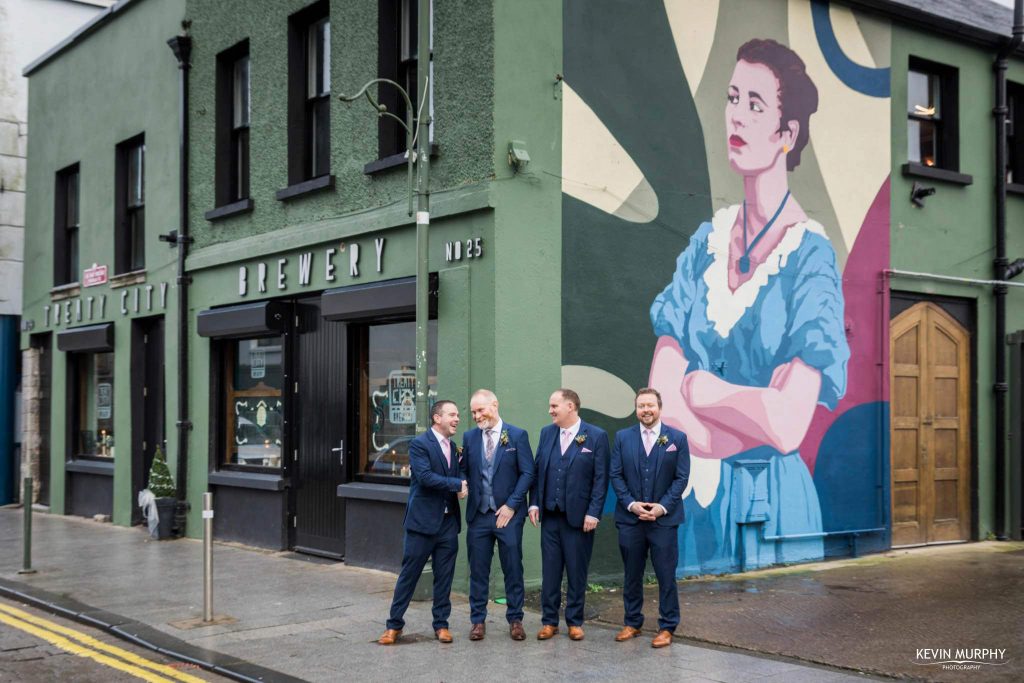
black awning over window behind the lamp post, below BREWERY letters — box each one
[321,272,437,322]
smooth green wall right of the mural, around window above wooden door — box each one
[891,25,1024,538]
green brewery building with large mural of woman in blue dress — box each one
[23,0,1024,586]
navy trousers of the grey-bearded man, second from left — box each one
[466,511,526,624]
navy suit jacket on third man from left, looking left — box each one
[529,422,608,527]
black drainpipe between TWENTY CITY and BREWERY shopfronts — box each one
[167,30,191,536]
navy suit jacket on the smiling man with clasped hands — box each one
[609,422,690,526]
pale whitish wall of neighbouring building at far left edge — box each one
[0,0,114,315]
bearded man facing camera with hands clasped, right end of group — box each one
[609,388,690,647]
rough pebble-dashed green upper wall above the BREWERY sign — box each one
[187,0,494,248]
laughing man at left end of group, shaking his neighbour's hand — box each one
[377,400,468,645]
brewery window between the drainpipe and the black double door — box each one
[224,337,285,468]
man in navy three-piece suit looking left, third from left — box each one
[529,389,608,640]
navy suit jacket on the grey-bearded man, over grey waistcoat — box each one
[462,422,534,523]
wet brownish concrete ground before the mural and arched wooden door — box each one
[587,542,1024,682]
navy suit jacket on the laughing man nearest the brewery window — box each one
[406,430,462,536]
